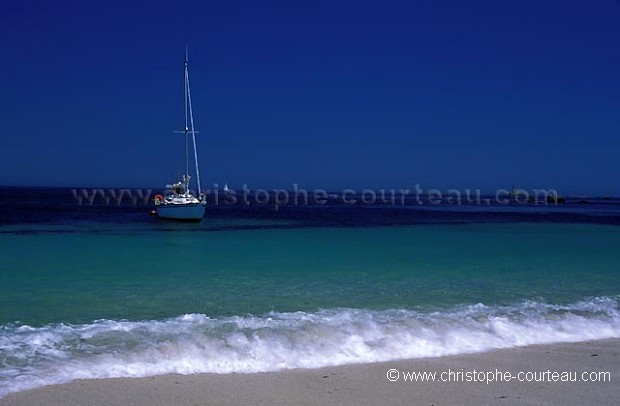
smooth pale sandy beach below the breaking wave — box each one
[0,340,620,406]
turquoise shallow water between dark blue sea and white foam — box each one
[0,223,620,325]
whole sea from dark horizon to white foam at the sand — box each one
[0,188,620,397]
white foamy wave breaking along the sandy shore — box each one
[0,297,620,397]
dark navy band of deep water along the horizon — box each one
[0,188,620,229]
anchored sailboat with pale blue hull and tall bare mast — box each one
[155,50,207,222]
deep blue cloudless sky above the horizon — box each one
[0,0,620,195]
